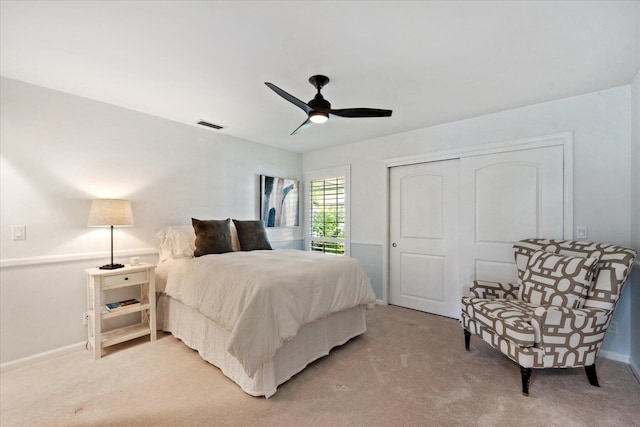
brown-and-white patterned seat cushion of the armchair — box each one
[462,297,537,347]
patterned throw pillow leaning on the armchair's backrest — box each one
[520,251,598,308]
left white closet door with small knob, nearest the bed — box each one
[389,160,460,316]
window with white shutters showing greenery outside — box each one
[306,167,349,255]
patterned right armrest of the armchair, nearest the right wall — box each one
[531,306,611,349]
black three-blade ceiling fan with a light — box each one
[264,75,392,135]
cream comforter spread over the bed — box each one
[156,250,375,376]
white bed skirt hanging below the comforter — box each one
[157,294,367,398]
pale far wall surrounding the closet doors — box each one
[303,86,631,357]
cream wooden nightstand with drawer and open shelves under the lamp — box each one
[85,263,156,359]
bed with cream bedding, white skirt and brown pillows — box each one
[156,220,375,398]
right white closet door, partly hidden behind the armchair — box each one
[460,145,564,285]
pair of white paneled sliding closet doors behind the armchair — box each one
[389,145,564,318]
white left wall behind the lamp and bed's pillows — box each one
[0,78,302,363]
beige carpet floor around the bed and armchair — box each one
[0,306,640,427]
